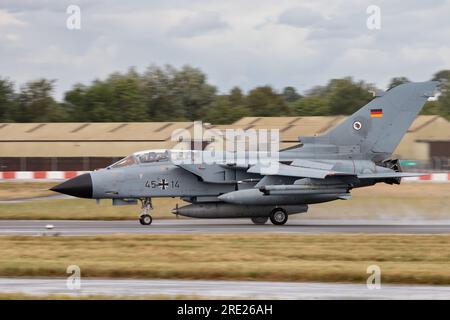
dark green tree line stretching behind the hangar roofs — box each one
[0,65,450,124]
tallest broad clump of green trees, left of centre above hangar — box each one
[65,65,216,121]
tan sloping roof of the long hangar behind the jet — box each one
[0,116,450,157]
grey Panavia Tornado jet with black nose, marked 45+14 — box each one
[51,82,438,225]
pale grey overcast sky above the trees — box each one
[0,0,450,99]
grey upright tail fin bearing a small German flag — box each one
[320,81,439,160]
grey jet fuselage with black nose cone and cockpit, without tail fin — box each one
[53,148,376,205]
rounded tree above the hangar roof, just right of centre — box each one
[246,86,291,117]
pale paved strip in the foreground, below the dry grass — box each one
[0,278,450,299]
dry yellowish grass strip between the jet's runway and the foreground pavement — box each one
[0,234,450,285]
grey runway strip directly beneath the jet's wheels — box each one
[0,219,450,236]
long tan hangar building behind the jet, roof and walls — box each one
[0,116,450,171]
